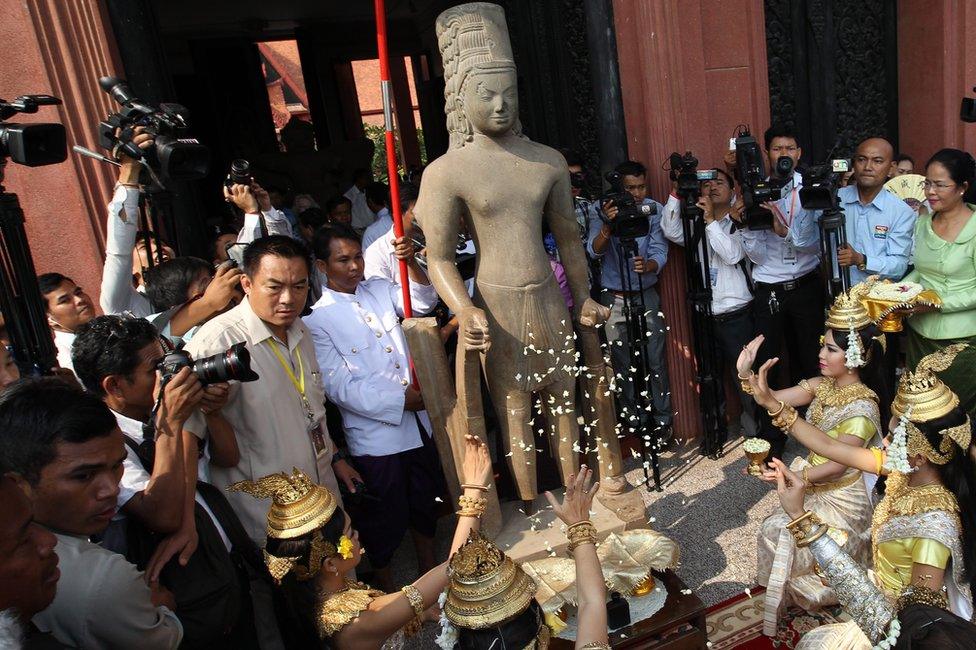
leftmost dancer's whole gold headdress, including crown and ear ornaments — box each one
[227,468,339,582]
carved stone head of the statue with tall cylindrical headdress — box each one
[436,2,521,148]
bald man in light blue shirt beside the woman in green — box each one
[837,138,915,284]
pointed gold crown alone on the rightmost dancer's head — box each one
[891,343,966,422]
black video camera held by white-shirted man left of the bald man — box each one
[735,129,793,230]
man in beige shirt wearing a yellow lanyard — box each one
[184,235,361,548]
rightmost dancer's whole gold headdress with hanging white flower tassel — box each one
[885,343,972,473]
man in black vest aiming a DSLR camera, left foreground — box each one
[73,316,256,648]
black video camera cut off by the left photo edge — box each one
[0,95,68,167]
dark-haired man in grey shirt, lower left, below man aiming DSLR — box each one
[0,378,183,650]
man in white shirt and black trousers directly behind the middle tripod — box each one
[661,169,757,440]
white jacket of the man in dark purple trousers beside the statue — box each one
[305,278,437,456]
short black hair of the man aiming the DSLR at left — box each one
[71,316,159,397]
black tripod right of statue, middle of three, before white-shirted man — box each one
[681,193,724,458]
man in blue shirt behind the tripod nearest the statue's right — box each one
[587,160,672,436]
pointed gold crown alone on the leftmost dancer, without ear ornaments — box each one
[227,468,338,539]
